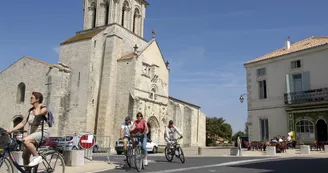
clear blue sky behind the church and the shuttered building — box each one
[0,0,328,132]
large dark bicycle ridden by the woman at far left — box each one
[0,128,65,173]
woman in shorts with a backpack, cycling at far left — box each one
[7,92,49,167]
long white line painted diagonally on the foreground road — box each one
[148,158,282,173]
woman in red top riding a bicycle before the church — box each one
[130,112,148,166]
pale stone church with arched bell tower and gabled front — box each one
[0,0,206,148]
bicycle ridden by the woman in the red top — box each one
[130,133,144,172]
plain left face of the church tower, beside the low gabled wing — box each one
[59,39,94,134]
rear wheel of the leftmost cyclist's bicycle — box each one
[38,151,65,173]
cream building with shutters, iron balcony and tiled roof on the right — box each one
[244,37,328,143]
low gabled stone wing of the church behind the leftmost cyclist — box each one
[0,57,69,136]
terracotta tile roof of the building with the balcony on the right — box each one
[244,36,328,65]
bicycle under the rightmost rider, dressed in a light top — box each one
[165,138,186,163]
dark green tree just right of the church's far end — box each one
[206,117,232,145]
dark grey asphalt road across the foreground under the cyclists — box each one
[95,156,328,173]
